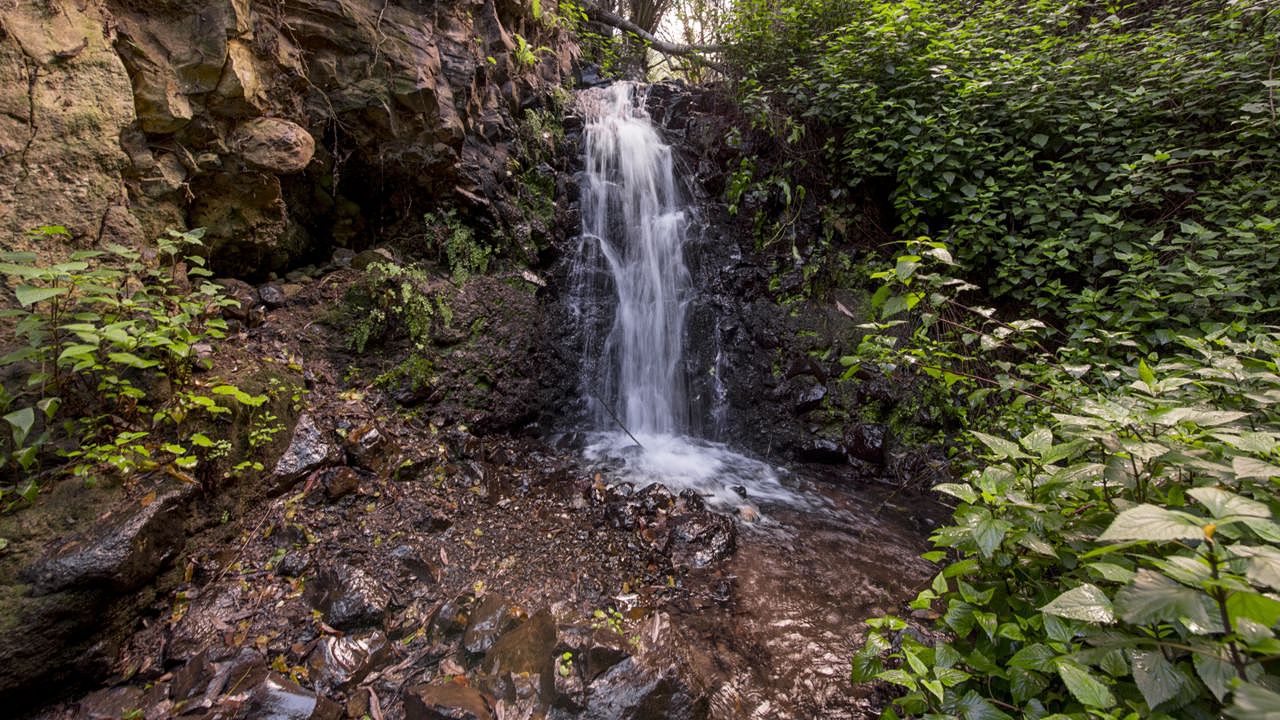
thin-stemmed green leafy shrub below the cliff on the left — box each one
[0,227,276,509]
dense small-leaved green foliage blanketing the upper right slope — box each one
[733,0,1280,343]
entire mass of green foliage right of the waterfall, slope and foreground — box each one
[730,0,1280,719]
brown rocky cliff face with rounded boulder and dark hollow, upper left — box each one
[0,0,576,275]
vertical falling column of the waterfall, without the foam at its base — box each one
[577,83,690,434]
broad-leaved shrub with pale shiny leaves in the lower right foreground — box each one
[851,238,1280,717]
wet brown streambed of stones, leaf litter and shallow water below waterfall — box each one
[3,258,931,719]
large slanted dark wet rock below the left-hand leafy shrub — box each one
[23,486,196,596]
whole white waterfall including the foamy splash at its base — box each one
[570,83,799,505]
